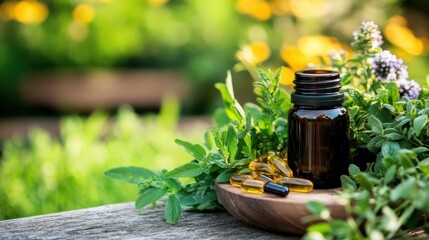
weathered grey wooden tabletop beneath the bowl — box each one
[0,203,299,239]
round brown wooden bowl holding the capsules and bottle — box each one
[216,183,346,235]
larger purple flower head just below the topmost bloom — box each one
[372,51,408,82]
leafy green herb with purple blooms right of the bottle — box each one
[304,22,429,239]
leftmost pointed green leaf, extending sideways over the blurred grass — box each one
[104,167,156,184]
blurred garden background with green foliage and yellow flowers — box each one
[0,0,429,219]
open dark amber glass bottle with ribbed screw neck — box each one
[288,70,349,189]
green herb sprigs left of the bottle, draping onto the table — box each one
[105,69,290,224]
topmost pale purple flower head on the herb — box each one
[352,21,383,53]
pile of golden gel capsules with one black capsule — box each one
[230,152,313,197]
